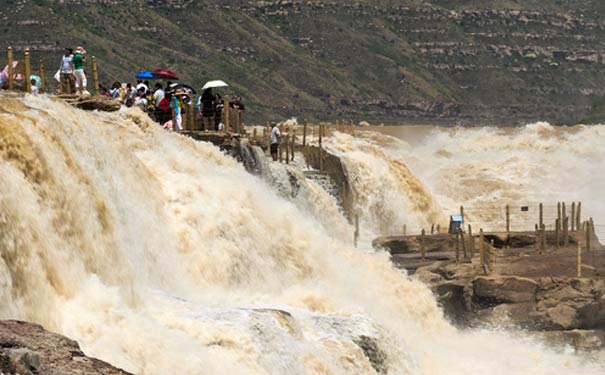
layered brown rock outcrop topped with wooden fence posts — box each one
[374,233,605,351]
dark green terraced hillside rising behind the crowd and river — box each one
[0,0,605,124]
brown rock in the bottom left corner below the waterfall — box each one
[0,320,132,375]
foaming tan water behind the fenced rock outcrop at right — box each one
[327,123,605,238]
